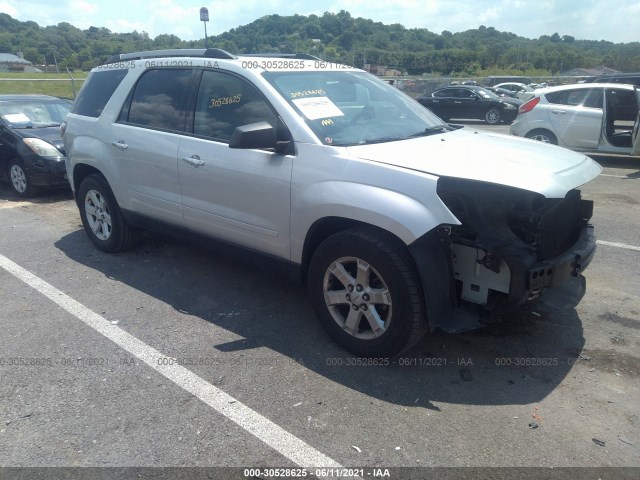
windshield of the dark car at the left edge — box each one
[0,99,71,128]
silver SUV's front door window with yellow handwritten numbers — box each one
[193,70,277,142]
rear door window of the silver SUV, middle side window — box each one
[120,69,193,132]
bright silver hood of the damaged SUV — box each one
[348,128,602,198]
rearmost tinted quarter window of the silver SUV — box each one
[71,69,128,118]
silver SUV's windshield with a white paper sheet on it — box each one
[263,71,449,146]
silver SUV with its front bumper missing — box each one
[63,49,601,357]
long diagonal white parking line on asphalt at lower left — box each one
[0,255,341,468]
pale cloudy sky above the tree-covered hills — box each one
[0,0,640,43]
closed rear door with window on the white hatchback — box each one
[545,87,604,150]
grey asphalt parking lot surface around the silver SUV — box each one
[0,124,640,478]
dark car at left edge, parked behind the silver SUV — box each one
[0,95,71,197]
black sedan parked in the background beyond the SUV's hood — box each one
[416,85,523,124]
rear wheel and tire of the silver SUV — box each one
[78,174,134,253]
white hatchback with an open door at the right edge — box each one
[511,83,640,155]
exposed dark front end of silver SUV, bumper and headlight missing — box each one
[410,177,596,332]
